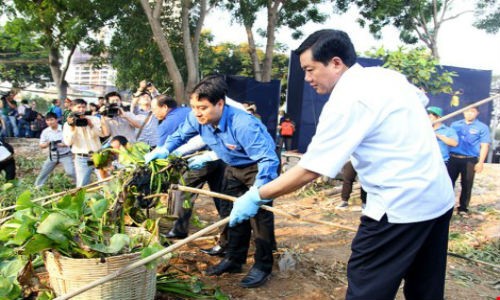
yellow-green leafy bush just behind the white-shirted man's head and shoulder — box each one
[365,47,456,94]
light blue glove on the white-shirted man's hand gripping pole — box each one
[229,186,271,227]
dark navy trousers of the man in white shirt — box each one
[346,209,453,300]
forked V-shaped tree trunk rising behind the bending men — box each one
[141,0,210,102]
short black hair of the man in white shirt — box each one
[294,29,357,67]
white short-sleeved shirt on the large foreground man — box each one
[299,64,455,223]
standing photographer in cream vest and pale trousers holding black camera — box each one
[63,99,109,187]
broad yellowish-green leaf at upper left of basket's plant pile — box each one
[37,212,78,244]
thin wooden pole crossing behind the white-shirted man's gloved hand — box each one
[171,184,357,232]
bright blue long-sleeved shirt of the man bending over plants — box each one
[164,105,279,187]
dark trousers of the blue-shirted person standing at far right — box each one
[446,155,478,212]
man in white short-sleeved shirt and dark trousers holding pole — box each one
[230,30,455,299]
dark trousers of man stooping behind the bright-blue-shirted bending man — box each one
[173,159,229,247]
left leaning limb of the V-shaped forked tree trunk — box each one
[141,0,185,101]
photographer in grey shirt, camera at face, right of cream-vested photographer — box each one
[99,92,135,143]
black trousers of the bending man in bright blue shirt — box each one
[223,164,276,272]
